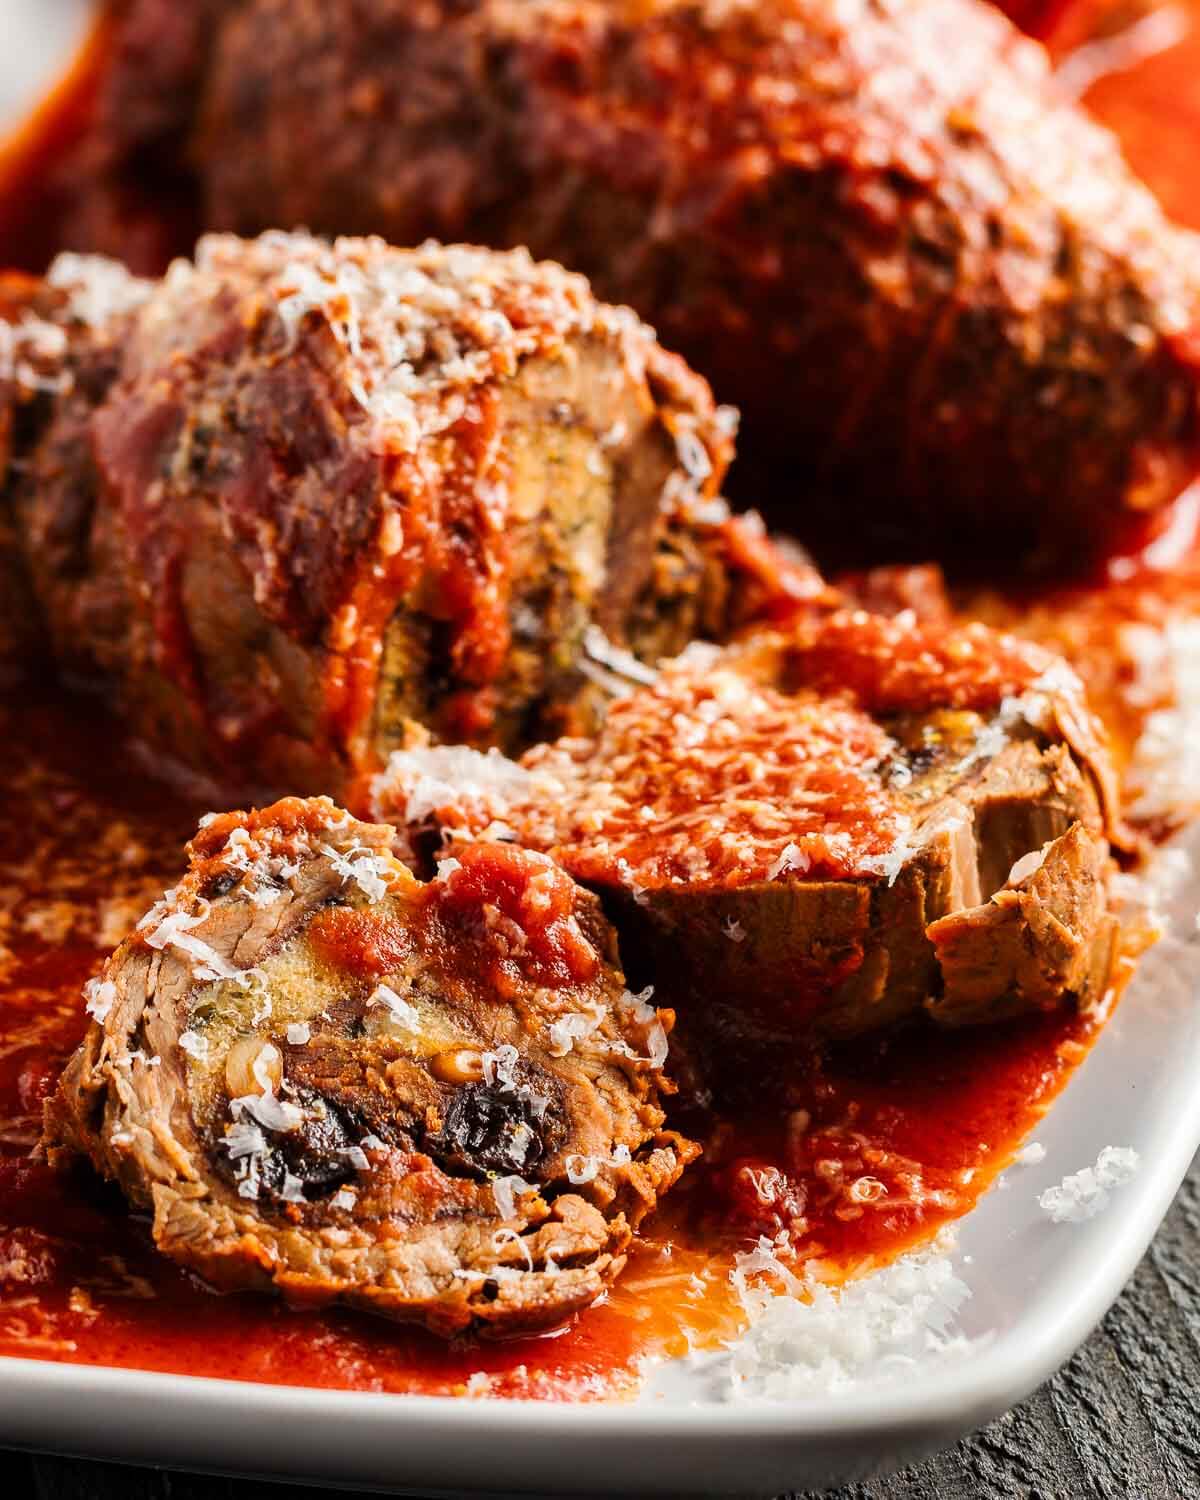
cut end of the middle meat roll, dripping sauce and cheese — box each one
[6,234,821,792]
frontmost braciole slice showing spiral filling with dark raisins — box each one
[47,798,695,1335]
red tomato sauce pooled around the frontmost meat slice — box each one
[0,693,1110,1400]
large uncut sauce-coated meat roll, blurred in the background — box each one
[65,0,1200,570]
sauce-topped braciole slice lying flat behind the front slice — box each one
[375,611,1119,1041]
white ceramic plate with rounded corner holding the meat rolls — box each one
[0,0,1200,1496]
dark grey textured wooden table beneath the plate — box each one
[9,1152,1200,1500]
